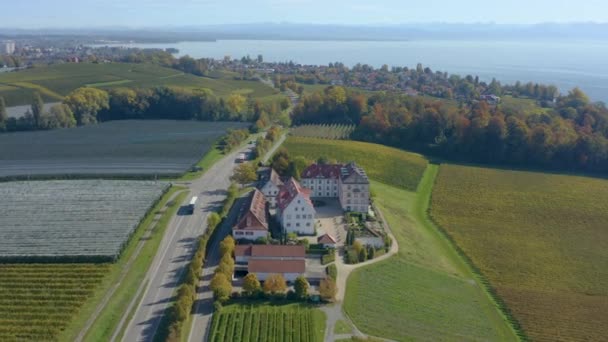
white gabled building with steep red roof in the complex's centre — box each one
[277,178,316,235]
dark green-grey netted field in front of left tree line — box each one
[0,120,245,178]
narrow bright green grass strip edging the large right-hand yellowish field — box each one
[426,164,530,342]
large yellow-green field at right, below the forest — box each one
[432,165,608,341]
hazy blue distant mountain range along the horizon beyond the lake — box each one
[0,23,608,43]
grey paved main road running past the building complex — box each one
[123,146,250,342]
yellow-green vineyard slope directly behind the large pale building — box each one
[284,136,428,190]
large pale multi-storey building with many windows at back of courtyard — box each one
[302,163,370,213]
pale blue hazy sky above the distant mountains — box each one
[0,0,608,28]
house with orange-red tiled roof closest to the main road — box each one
[232,189,268,241]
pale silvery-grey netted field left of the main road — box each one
[0,180,168,261]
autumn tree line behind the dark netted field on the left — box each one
[0,87,290,132]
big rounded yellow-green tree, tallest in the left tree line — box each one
[63,88,110,125]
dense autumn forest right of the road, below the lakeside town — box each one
[292,87,608,172]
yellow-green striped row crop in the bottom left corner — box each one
[0,264,109,341]
